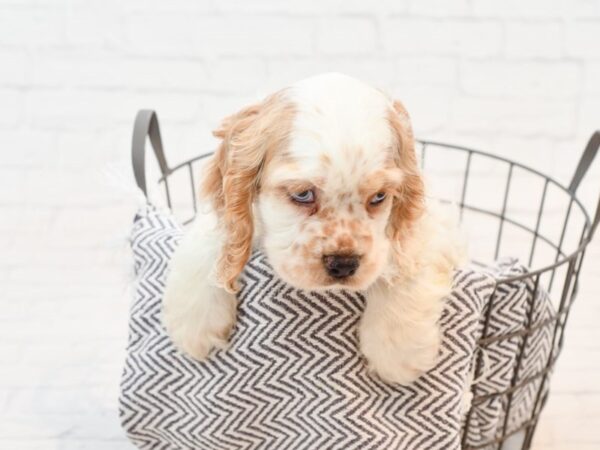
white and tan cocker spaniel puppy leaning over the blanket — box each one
[163,74,462,384]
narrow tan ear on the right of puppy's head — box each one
[389,101,425,240]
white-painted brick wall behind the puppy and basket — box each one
[0,0,600,449]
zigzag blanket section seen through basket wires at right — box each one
[467,259,555,449]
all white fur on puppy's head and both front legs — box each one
[164,74,463,384]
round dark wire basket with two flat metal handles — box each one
[132,110,600,449]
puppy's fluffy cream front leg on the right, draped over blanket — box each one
[359,201,466,384]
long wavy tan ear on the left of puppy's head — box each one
[201,91,291,292]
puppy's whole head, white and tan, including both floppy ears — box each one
[204,74,423,290]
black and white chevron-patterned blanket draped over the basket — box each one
[120,206,551,450]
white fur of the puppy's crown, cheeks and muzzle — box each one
[257,73,400,290]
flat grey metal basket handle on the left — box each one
[131,109,171,196]
